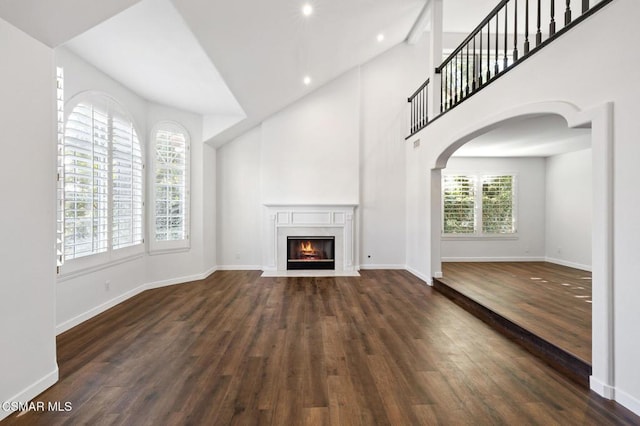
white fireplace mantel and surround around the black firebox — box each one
[263,204,359,277]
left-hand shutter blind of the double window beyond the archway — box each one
[442,175,476,234]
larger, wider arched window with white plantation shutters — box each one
[64,95,143,260]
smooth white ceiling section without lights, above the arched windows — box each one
[65,0,244,119]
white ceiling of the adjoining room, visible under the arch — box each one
[453,115,591,157]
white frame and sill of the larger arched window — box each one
[61,91,145,277]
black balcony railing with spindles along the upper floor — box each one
[409,0,613,137]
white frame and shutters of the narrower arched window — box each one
[149,120,191,254]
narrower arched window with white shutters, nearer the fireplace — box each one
[152,122,190,250]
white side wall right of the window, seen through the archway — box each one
[545,149,593,270]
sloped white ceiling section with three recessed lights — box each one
[174,0,426,144]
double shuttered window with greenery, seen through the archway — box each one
[442,174,516,236]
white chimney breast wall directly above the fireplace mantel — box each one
[260,69,360,204]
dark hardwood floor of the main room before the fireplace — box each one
[6,271,640,425]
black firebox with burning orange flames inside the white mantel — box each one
[287,236,336,270]
